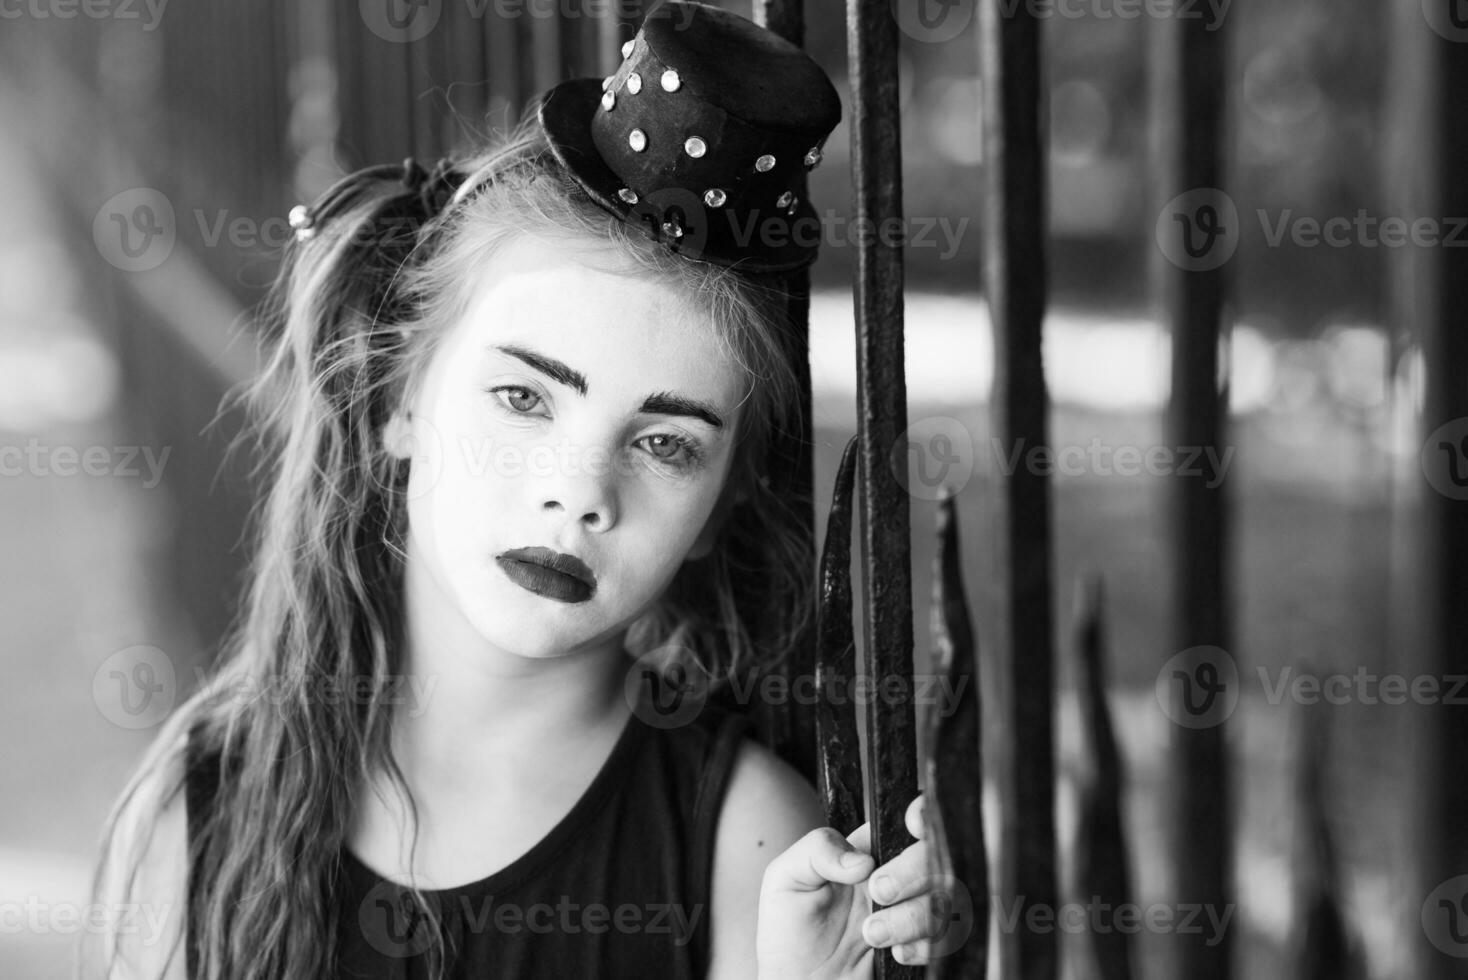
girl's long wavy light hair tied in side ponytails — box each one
[88,109,810,980]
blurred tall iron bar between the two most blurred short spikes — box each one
[1151,9,1233,980]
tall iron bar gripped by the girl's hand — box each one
[847,0,919,980]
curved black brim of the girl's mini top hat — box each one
[539,78,821,273]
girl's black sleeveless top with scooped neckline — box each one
[186,703,749,980]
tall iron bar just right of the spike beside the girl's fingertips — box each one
[979,0,1057,980]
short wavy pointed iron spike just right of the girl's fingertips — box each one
[919,489,989,980]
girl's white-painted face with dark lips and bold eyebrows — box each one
[388,236,746,657]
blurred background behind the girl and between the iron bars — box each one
[0,0,1468,980]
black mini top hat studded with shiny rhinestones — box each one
[540,0,841,273]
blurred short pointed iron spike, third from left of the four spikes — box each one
[1075,575,1133,980]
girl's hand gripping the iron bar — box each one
[756,795,942,980]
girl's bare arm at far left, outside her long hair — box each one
[82,742,188,980]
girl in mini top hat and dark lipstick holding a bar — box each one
[88,3,938,980]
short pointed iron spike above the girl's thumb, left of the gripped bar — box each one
[816,436,863,833]
